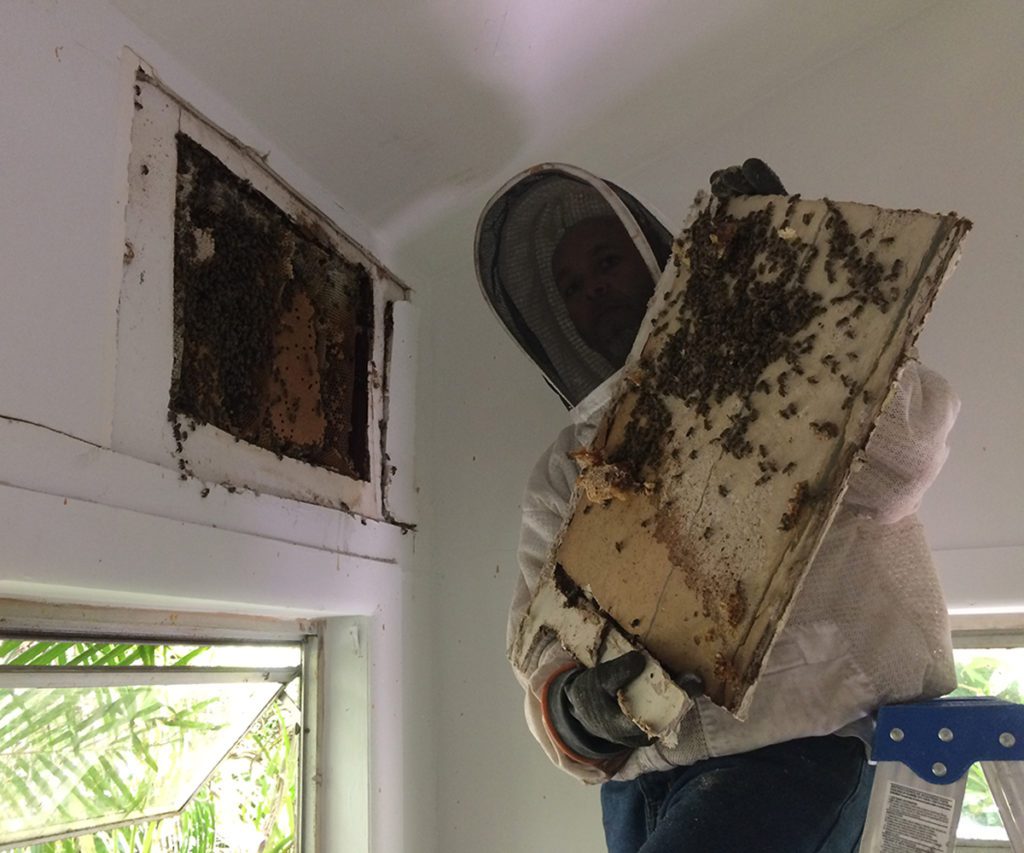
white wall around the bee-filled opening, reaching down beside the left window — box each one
[0,0,432,851]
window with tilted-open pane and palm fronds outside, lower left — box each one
[0,614,317,853]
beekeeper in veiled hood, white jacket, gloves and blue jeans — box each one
[475,160,959,853]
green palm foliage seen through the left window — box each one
[0,639,301,853]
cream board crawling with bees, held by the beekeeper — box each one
[520,191,970,729]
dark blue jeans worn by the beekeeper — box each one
[601,735,874,853]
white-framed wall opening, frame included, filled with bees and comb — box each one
[112,51,413,522]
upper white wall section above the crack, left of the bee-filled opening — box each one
[0,0,385,444]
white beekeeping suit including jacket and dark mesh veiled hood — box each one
[476,165,959,782]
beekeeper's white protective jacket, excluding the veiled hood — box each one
[508,361,959,782]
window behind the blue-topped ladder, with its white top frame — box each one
[951,631,1024,850]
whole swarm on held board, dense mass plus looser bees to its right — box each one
[609,196,903,530]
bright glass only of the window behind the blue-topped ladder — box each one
[951,648,1024,841]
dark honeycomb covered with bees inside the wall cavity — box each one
[170,133,373,480]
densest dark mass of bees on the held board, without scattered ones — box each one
[613,197,825,489]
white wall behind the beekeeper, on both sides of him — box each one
[407,0,1024,853]
